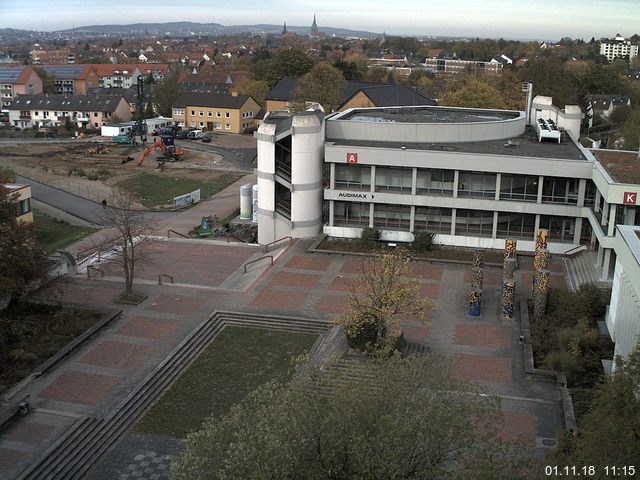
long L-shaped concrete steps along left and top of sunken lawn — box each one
[18,311,329,480]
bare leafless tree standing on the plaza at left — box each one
[102,192,157,299]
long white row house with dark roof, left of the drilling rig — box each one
[7,94,131,129]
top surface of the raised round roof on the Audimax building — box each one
[333,106,520,123]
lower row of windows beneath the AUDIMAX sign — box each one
[333,201,575,243]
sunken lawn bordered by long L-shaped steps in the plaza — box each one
[134,326,317,438]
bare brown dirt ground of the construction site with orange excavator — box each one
[0,142,221,201]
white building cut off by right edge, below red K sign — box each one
[607,225,640,369]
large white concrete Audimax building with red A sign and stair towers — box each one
[257,97,640,280]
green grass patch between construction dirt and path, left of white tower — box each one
[118,173,242,207]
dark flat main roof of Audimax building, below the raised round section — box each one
[327,126,588,161]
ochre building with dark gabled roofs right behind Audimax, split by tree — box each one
[266,77,436,112]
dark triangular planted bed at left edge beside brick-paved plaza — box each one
[0,303,101,393]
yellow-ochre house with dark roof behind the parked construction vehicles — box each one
[172,93,261,133]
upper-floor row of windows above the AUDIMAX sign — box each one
[334,164,579,205]
